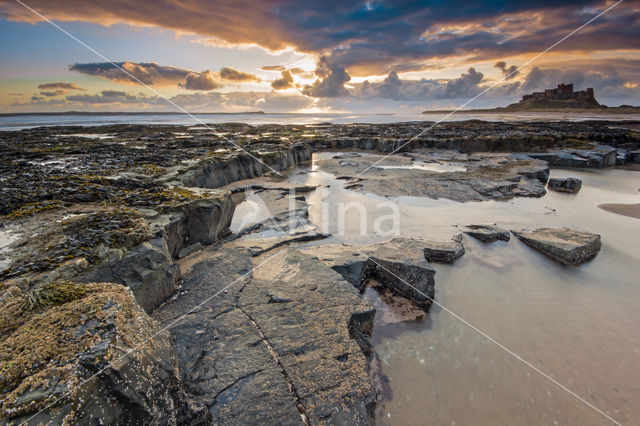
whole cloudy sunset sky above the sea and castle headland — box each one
[0,0,640,113]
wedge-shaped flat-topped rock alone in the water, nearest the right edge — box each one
[513,228,602,266]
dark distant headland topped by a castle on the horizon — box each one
[423,83,640,114]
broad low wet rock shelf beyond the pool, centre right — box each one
[317,153,549,202]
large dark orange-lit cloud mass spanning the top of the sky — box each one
[0,0,640,75]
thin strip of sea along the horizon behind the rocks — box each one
[0,111,640,131]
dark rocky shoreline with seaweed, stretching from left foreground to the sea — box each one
[0,121,640,424]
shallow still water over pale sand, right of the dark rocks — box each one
[292,155,640,425]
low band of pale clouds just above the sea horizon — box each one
[12,61,640,113]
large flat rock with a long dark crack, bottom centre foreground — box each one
[153,248,376,424]
